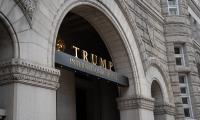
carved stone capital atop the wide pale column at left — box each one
[0,59,60,89]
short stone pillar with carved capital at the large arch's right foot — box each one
[117,97,154,120]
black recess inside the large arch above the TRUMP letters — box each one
[58,13,111,60]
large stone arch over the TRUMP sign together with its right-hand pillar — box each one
[49,0,152,120]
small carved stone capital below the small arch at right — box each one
[154,104,176,116]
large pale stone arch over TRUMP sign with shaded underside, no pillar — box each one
[50,0,148,96]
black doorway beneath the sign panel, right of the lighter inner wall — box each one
[76,72,119,120]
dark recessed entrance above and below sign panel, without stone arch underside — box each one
[56,12,119,120]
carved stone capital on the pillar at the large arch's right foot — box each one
[117,97,154,111]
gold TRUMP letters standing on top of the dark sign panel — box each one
[72,46,113,70]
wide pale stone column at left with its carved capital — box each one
[0,59,60,120]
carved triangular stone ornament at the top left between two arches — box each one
[15,0,38,25]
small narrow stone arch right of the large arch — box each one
[146,61,175,120]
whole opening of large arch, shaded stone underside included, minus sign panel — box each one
[56,5,132,120]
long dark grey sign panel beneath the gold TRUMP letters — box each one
[55,51,128,86]
